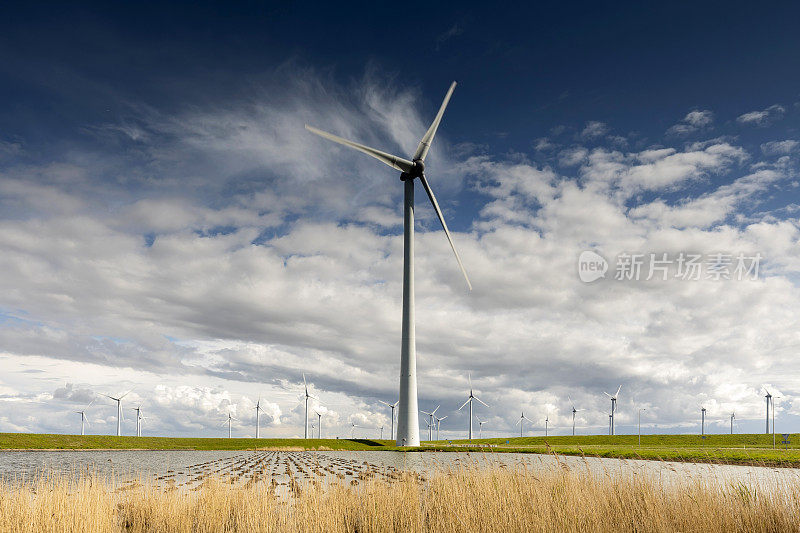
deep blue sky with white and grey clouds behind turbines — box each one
[0,3,800,436]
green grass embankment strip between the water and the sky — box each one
[0,433,800,467]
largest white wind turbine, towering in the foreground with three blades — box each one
[306,82,472,446]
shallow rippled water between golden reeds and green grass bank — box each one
[0,450,800,491]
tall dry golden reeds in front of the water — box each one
[0,467,800,533]
